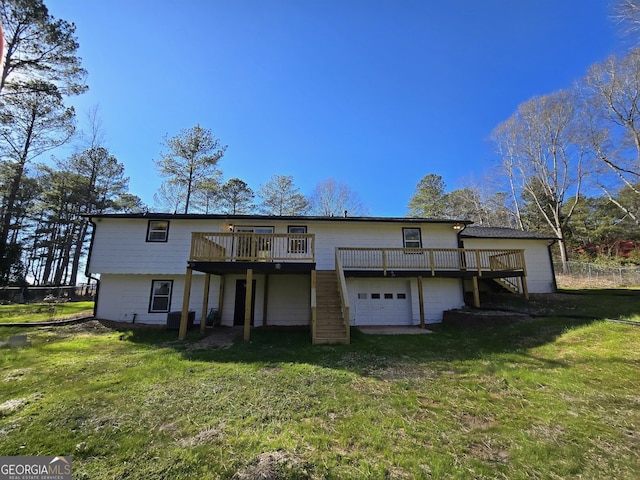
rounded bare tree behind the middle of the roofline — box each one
[309,178,367,217]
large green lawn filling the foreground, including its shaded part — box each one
[0,290,640,479]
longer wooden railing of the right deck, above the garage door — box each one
[337,248,525,276]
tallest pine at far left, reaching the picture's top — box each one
[0,0,87,283]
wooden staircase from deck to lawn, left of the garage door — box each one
[313,270,349,343]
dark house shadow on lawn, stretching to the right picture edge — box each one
[52,290,640,374]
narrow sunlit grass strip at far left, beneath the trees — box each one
[0,302,93,323]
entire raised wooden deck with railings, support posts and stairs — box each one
[180,232,528,343]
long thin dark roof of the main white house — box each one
[83,212,472,225]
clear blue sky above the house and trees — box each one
[45,0,621,216]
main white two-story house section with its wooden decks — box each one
[87,213,556,343]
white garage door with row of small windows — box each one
[355,279,412,325]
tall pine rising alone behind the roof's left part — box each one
[156,125,227,213]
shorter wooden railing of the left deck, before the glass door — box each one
[189,232,315,262]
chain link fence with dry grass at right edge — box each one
[553,262,640,288]
